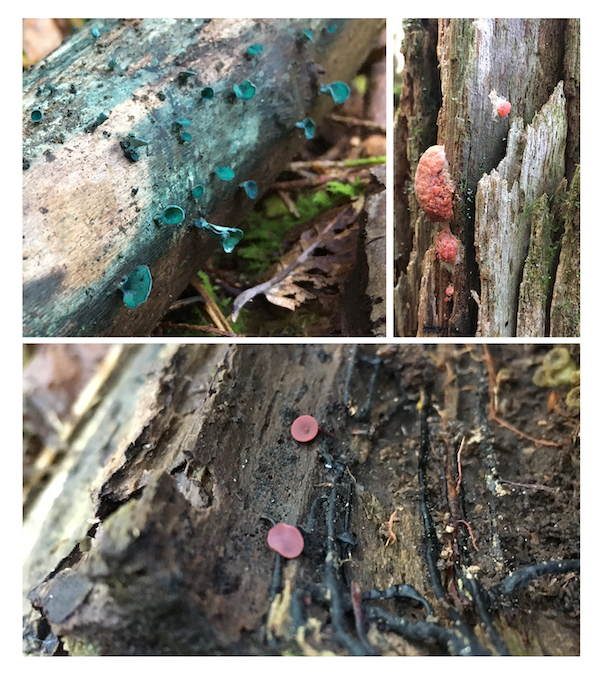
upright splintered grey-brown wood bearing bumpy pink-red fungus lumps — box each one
[395,19,580,337]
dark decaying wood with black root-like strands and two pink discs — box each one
[24,344,579,655]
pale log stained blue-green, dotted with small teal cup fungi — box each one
[23,19,384,336]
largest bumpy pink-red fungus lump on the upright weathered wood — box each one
[414,145,453,223]
